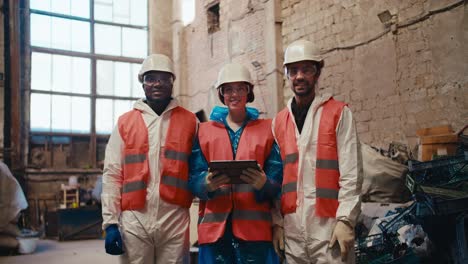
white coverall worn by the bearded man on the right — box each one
[272,95,362,264]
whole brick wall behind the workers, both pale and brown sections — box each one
[179,0,468,147]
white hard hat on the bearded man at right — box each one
[283,39,323,67]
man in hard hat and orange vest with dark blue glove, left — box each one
[101,54,197,263]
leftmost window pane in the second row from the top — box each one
[31,14,51,48]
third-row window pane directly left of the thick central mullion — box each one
[70,57,91,94]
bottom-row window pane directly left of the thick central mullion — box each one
[71,96,91,133]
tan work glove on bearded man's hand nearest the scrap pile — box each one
[329,220,354,261]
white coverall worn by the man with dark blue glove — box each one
[101,99,190,264]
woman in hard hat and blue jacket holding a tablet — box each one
[189,63,282,263]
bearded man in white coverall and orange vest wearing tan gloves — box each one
[272,40,362,264]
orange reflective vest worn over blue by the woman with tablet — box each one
[198,119,274,244]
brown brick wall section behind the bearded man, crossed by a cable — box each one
[281,0,468,147]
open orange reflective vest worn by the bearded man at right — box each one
[275,98,346,217]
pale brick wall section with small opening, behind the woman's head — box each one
[179,0,274,117]
